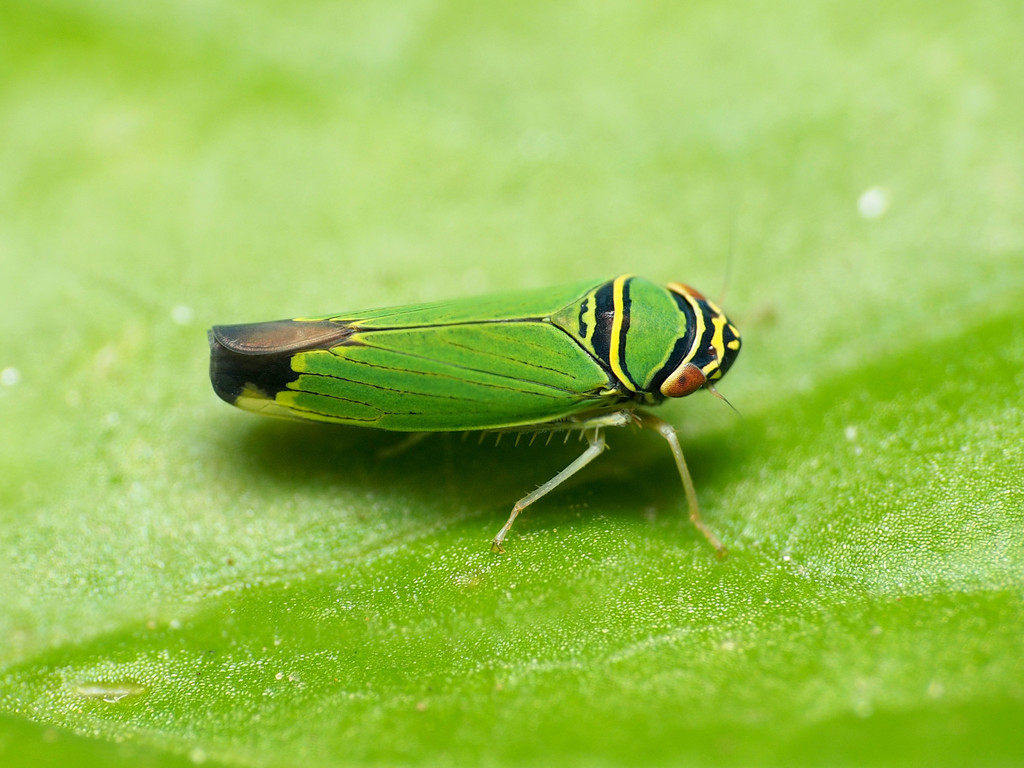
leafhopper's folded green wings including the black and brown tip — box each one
[211,284,620,431]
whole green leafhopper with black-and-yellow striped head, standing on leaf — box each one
[209,274,740,553]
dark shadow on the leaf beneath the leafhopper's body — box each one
[234,421,745,539]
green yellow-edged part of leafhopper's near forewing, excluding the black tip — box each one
[275,319,610,431]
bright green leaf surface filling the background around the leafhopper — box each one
[0,0,1024,766]
